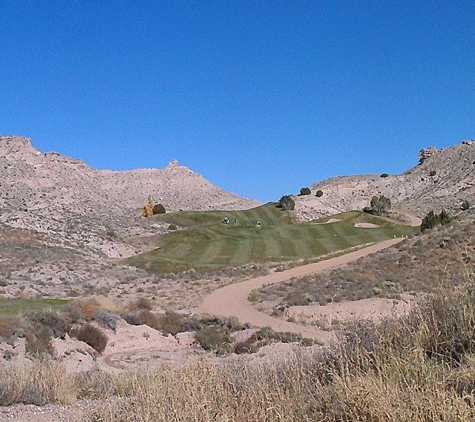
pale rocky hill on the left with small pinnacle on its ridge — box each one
[0,136,260,257]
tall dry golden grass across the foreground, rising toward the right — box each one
[0,285,475,422]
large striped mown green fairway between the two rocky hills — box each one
[127,203,418,274]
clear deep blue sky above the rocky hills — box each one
[0,0,475,201]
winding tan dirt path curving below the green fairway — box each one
[201,238,403,344]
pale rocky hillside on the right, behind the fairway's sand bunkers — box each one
[295,140,475,221]
